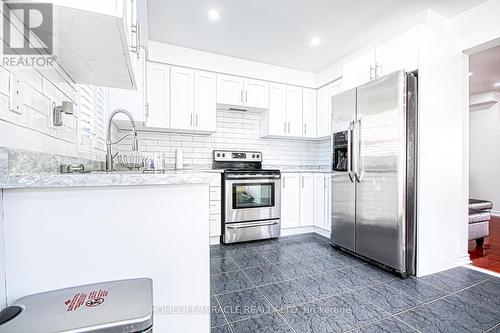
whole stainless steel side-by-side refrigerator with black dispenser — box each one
[331,70,417,276]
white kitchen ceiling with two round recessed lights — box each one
[148,0,485,72]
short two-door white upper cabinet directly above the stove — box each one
[217,74,269,110]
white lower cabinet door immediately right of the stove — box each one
[281,173,300,229]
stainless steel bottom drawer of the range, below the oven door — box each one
[223,219,281,244]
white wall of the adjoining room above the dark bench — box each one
[469,93,500,215]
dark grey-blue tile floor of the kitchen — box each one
[210,234,500,333]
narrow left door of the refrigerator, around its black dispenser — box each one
[331,89,356,251]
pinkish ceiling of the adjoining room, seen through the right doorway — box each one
[469,46,500,95]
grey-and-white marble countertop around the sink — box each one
[0,170,221,189]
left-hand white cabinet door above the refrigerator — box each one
[342,50,375,89]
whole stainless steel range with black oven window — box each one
[212,150,281,244]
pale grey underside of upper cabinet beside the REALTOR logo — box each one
[4,0,136,89]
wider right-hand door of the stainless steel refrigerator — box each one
[353,71,406,272]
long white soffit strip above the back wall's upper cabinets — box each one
[148,41,316,88]
